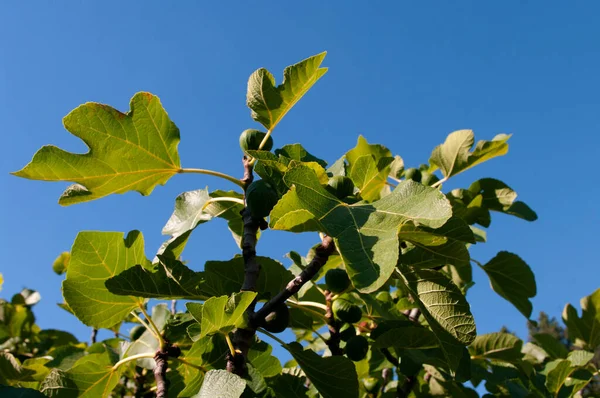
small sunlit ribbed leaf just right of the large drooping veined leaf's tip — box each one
[469,333,523,362]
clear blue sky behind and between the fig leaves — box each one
[0,0,600,360]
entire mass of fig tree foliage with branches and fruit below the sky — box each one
[7,53,600,397]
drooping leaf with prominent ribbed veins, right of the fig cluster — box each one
[402,270,476,372]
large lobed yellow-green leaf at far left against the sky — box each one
[13,93,180,206]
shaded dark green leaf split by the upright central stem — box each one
[201,256,294,300]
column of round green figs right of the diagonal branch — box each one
[325,268,369,362]
